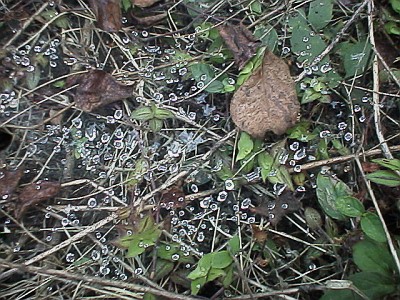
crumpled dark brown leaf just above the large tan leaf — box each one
[218,24,259,70]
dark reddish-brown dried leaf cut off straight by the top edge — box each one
[89,0,122,32]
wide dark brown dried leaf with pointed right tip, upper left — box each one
[67,70,133,112]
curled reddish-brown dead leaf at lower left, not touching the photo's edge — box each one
[14,181,61,219]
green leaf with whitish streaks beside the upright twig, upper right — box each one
[339,40,371,77]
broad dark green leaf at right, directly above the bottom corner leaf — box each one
[353,240,395,276]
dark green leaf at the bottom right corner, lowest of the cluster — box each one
[349,272,396,300]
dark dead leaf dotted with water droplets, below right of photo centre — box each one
[250,190,301,226]
